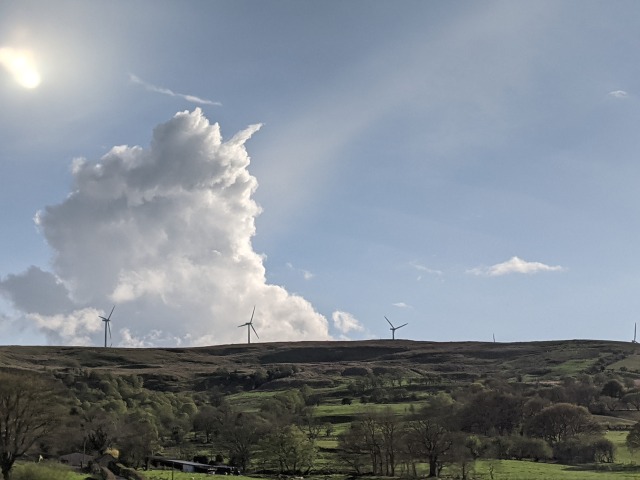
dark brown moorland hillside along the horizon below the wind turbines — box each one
[0,340,640,390]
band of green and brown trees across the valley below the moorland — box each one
[0,370,640,480]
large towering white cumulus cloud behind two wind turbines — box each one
[0,109,329,346]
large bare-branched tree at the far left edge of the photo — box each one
[0,373,61,480]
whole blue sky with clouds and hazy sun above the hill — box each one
[0,0,640,347]
